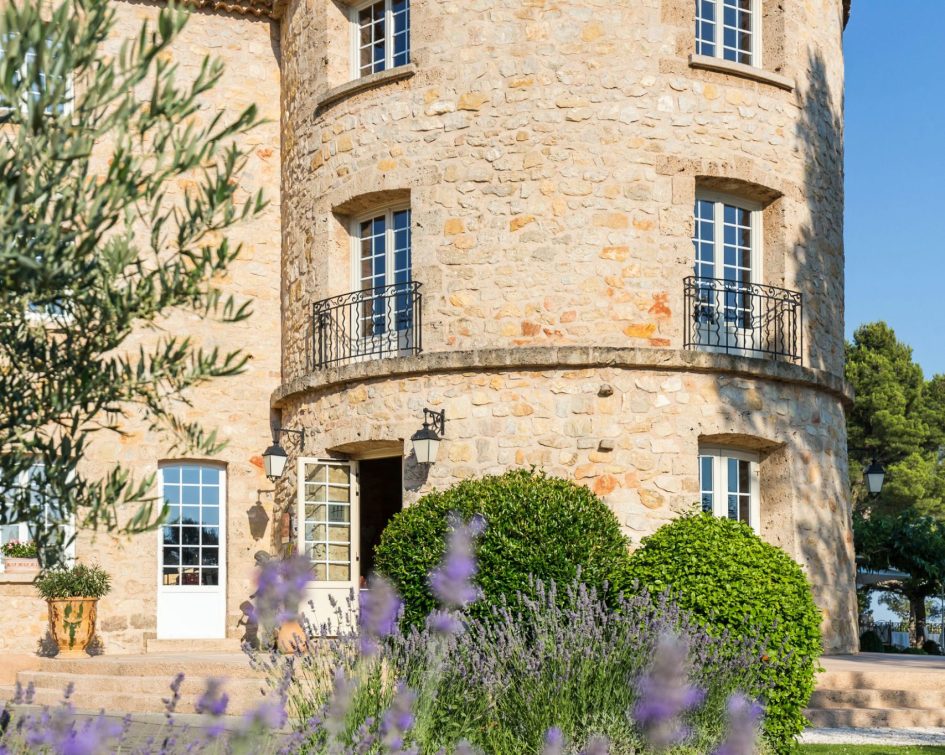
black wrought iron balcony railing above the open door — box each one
[312,281,422,369]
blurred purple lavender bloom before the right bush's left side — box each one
[633,634,705,750]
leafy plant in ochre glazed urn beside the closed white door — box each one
[36,564,111,658]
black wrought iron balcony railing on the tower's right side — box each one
[683,277,803,363]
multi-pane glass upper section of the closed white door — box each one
[161,463,225,586]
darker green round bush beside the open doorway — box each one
[375,470,629,625]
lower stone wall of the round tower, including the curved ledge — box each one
[280,349,856,652]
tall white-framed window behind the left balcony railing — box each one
[355,208,413,337]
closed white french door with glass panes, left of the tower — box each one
[157,462,226,640]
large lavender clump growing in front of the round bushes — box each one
[247,521,769,755]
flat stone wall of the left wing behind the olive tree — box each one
[0,2,280,653]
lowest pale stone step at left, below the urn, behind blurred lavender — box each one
[0,686,262,716]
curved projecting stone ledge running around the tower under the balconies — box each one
[271,346,853,409]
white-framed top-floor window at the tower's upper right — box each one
[696,0,761,67]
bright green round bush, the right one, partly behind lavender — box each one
[614,514,821,752]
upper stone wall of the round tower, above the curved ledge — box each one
[282,0,843,379]
